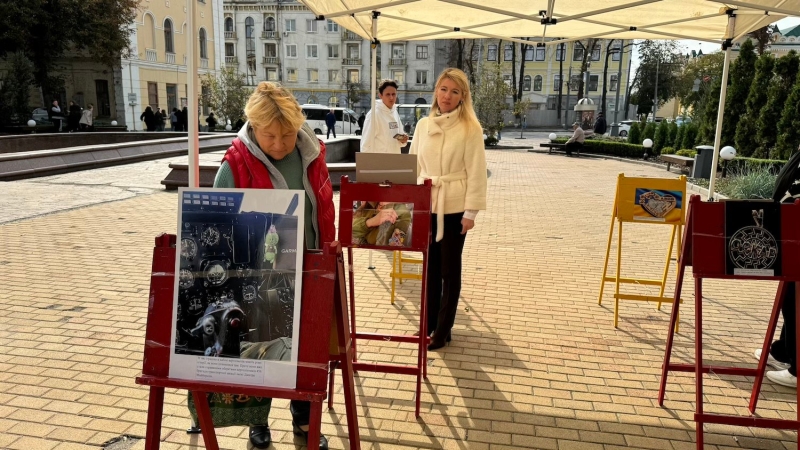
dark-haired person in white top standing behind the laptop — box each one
[361,80,408,153]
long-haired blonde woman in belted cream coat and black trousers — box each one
[411,68,487,350]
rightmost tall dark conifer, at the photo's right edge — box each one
[753,50,800,158]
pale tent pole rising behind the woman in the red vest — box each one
[186,0,200,188]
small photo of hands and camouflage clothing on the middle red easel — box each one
[352,201,414,247]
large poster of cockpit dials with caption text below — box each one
[170,189,305,387]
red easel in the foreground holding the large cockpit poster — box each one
[136,234,361,450]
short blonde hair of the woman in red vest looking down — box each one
[244,81,306,131]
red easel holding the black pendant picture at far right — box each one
[658,195,800,450]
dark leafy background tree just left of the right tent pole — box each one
[631,40,683,115]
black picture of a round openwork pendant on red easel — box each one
[725,200,781,277]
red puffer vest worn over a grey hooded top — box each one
[223,138,336,247]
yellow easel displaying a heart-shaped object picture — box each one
[597,173,687,328]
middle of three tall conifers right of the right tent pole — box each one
[734,53,775,156]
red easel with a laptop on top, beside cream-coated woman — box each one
[328,176,431,417]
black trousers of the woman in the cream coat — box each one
[427,213,467,339]
